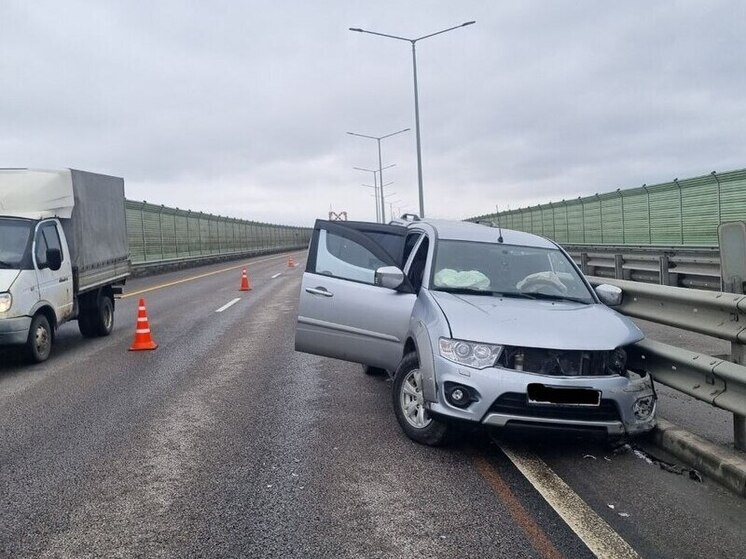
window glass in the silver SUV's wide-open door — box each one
[314,229,387,285]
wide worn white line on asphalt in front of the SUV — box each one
[498,442,640,559]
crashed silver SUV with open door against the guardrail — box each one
[295,219,656,445]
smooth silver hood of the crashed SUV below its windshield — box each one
[430,291,644,350]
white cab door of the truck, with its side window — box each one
[34,221,73,323]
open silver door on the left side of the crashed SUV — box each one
[295,220,417,370]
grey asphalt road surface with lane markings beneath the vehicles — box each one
[0,253,746,558]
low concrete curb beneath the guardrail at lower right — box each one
[650,418,746,497]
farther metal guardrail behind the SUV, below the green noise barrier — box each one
[563,245,720,291]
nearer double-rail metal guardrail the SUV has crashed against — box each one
[588,277,746,450]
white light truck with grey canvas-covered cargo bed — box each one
[0,169,130,363]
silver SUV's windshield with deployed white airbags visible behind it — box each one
[430,240,594,303]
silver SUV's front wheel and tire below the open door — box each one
[392,353,450,446]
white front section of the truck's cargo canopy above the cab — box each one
[0,169,75,219]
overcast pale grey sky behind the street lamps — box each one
[0,0,746,225]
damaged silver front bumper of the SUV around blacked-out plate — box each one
[429,357,656,436]
